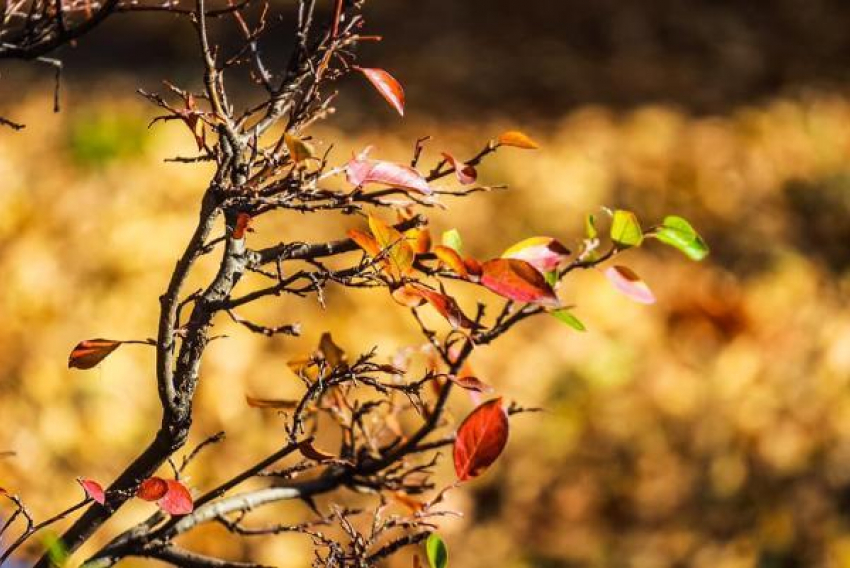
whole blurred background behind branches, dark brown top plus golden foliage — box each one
[0,0,850,568]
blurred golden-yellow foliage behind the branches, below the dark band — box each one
[0,85,850,568]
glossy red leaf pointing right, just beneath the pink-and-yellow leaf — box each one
[481,258,559,307]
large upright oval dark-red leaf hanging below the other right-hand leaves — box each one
[454,397,509,481]
